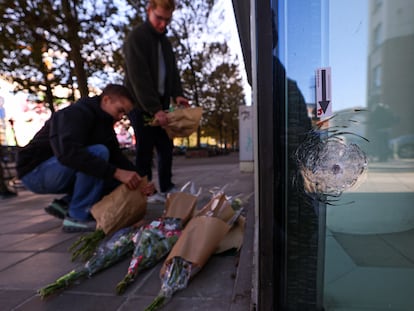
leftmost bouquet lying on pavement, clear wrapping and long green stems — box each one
[38,226,139,299]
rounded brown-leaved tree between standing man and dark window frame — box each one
[175,38,245,146]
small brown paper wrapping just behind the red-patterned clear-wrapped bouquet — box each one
[163,192,197,226]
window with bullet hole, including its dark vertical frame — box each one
[240,0,414,311]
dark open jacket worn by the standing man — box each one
[123,21,183,115]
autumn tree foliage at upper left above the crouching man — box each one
[0,0,139,111]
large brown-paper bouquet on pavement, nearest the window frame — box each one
[145,192,245,311]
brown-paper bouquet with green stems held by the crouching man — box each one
[69,177,148,261]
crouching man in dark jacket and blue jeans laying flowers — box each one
[17,84,153,232]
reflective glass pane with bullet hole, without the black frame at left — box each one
[275,0,414,311]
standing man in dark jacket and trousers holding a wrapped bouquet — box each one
[124,0,189,202]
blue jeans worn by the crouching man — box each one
[21,145,119,220]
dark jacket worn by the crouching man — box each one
[17,96,135,179]
